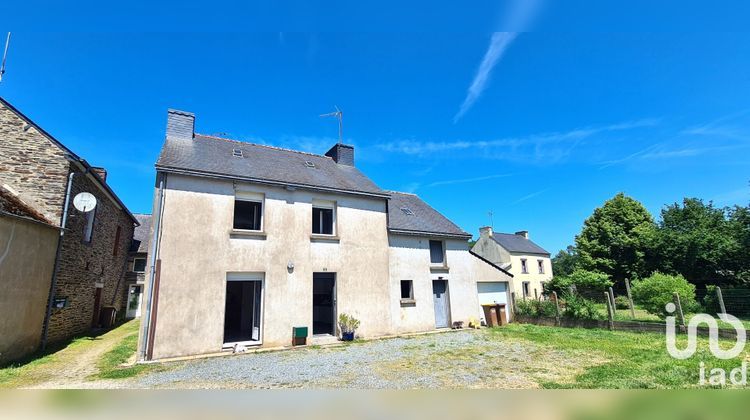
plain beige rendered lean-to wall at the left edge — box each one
[0,215,59,363]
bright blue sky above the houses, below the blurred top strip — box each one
[0,26,750,252]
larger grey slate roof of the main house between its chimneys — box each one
[156,134,388,197]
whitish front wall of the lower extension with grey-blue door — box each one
[389,235,512,332]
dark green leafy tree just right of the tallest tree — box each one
[651,198,742,285]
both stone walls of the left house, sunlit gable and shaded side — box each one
[0,98,137,342]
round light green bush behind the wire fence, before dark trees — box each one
[632,271,698,318]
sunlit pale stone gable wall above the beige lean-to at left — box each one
[0,102,69,224]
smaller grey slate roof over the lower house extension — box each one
[388,191,471,239]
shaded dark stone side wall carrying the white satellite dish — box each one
[49,171,133,342]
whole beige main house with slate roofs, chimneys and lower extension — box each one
[139,110,513,359]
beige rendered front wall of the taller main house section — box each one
[148,174,391,359]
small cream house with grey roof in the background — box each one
[471,226,552,299]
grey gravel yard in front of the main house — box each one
[134,330,592,389]
